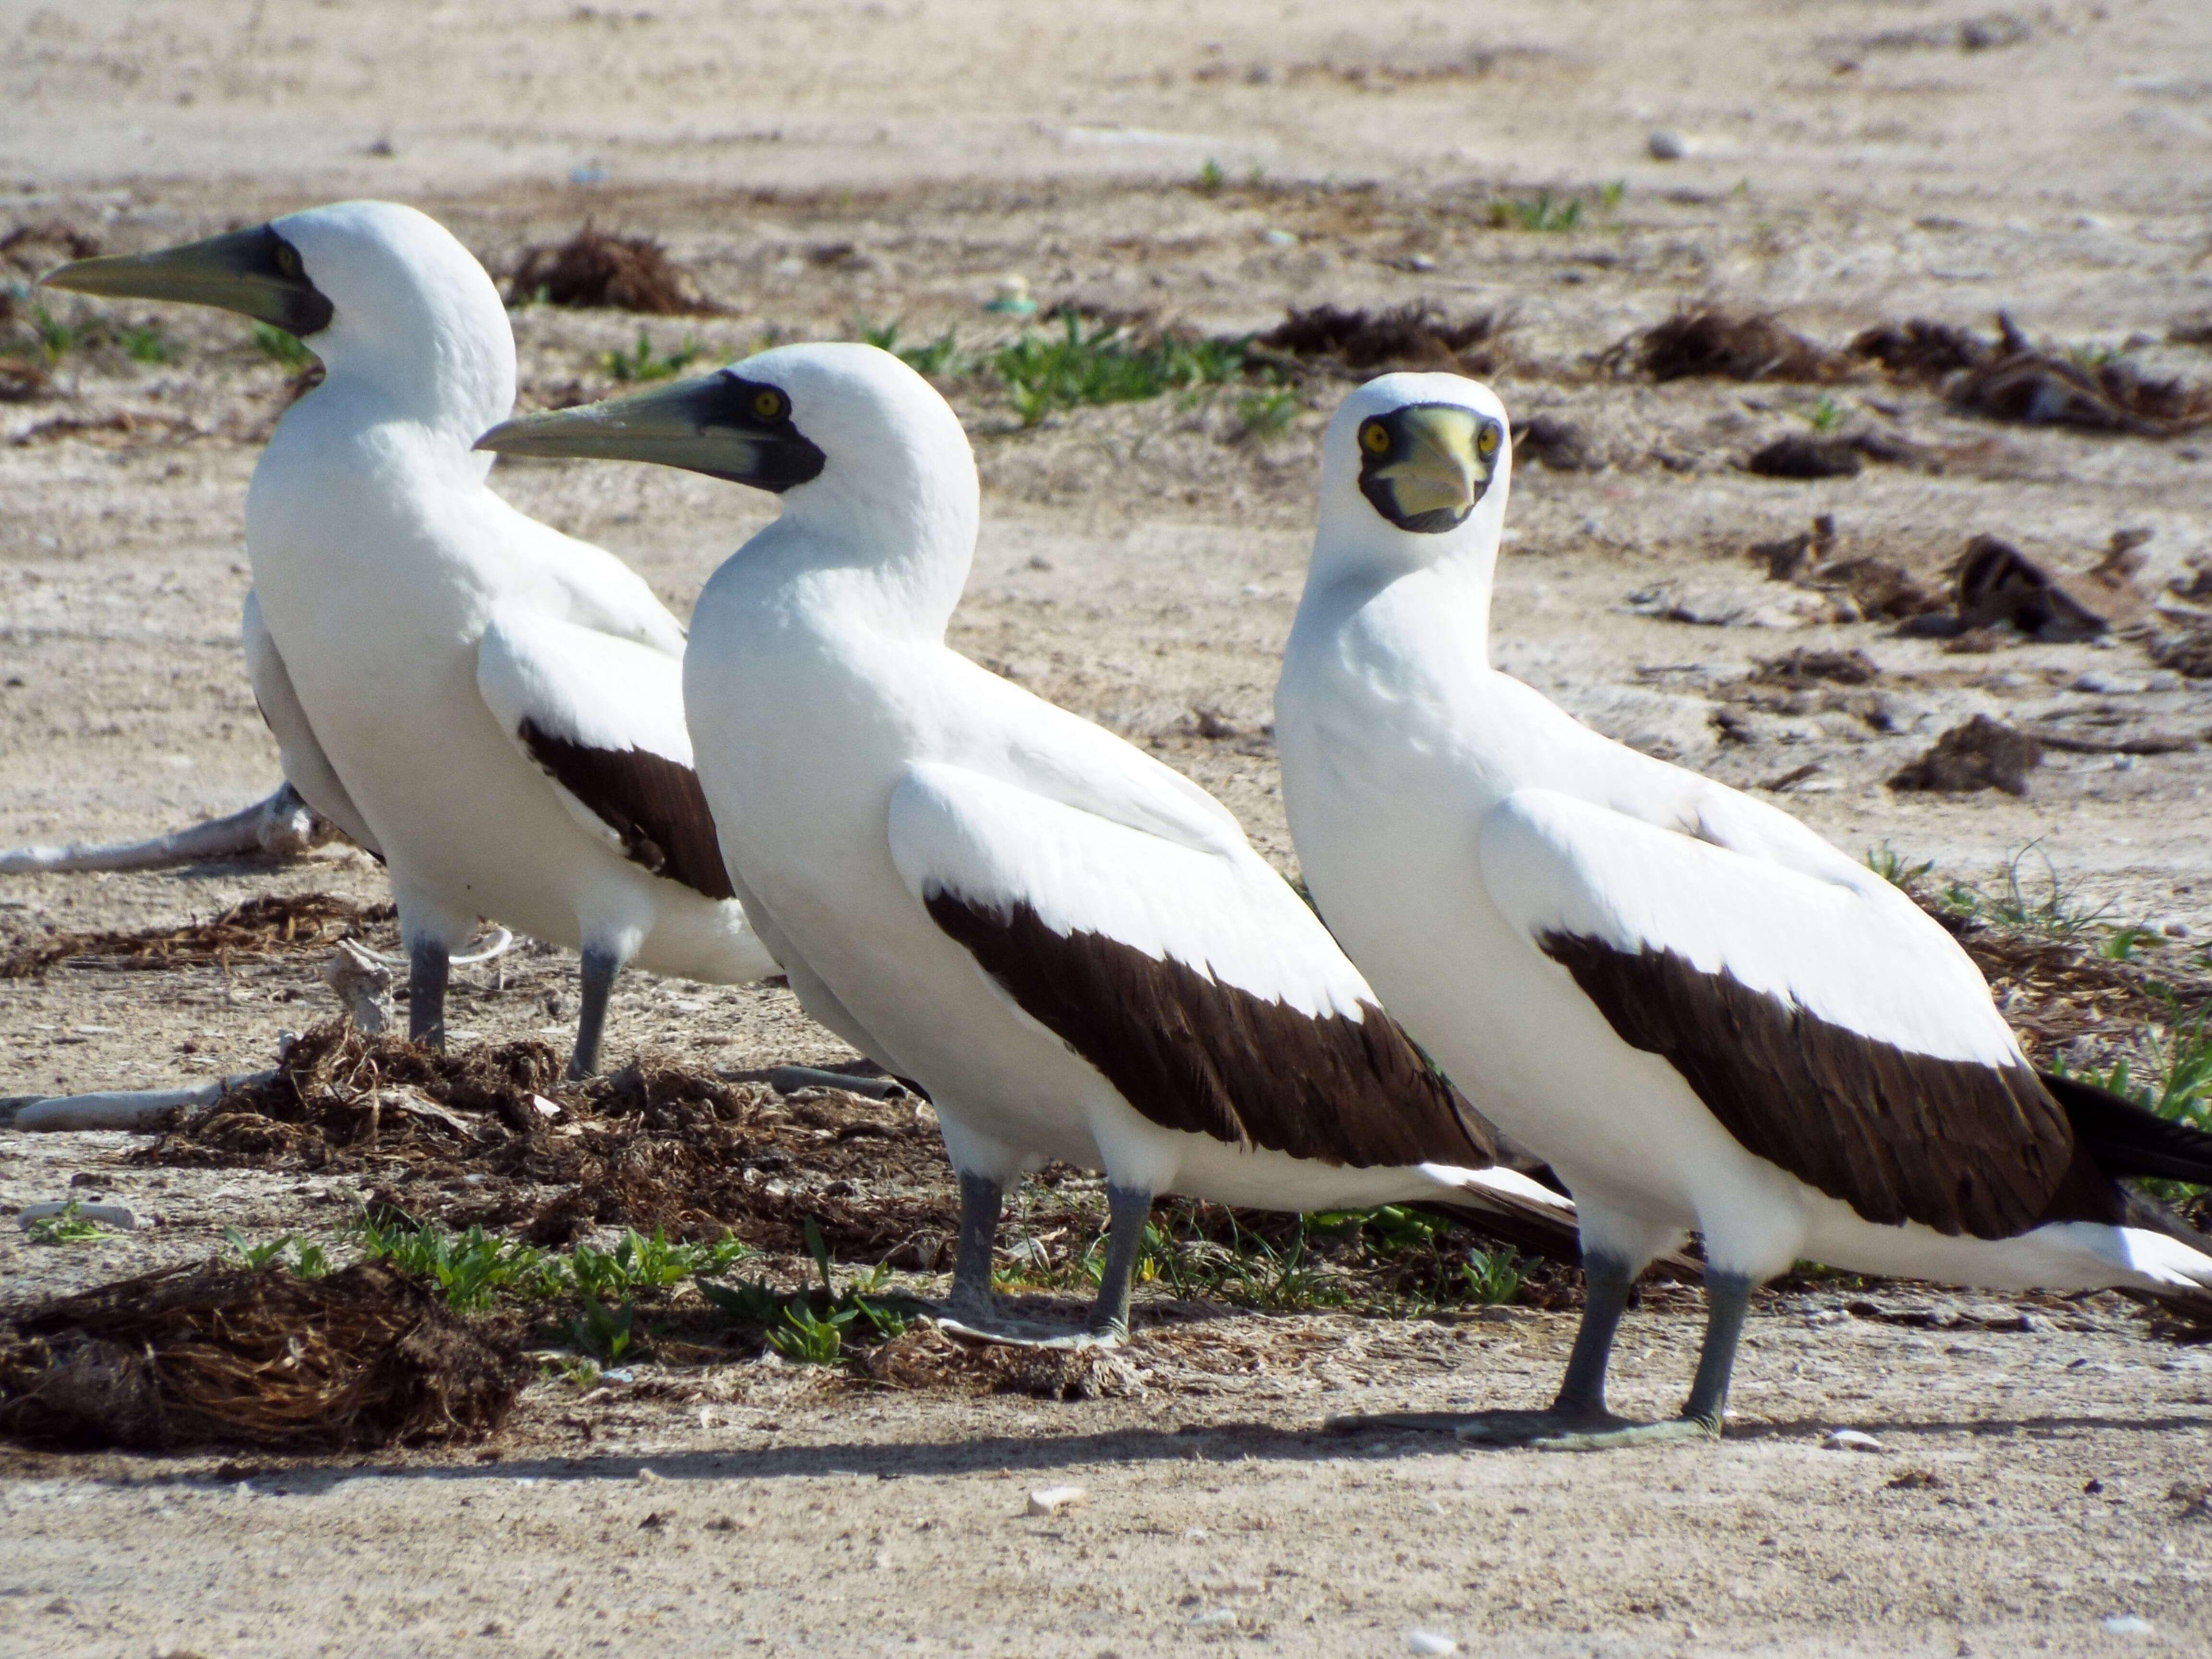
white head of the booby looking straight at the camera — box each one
[1307,374,1513,590]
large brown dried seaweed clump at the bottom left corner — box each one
[0,1263,522,1451]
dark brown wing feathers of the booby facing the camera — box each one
[1539,934,2124,1238]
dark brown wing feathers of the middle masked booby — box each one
[927,891,1498,1170]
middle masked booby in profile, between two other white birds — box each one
[484,345,1568,1334]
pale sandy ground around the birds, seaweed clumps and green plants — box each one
[0,0,2212,1657]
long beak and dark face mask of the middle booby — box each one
[476,370,823,491]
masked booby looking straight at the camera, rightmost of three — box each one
[1276,374,2212,1447]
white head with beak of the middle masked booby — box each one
[478,343,978,628]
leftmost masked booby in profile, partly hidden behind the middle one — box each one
[47,201,776,1075]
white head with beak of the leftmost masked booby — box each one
[47,201,516,445]
